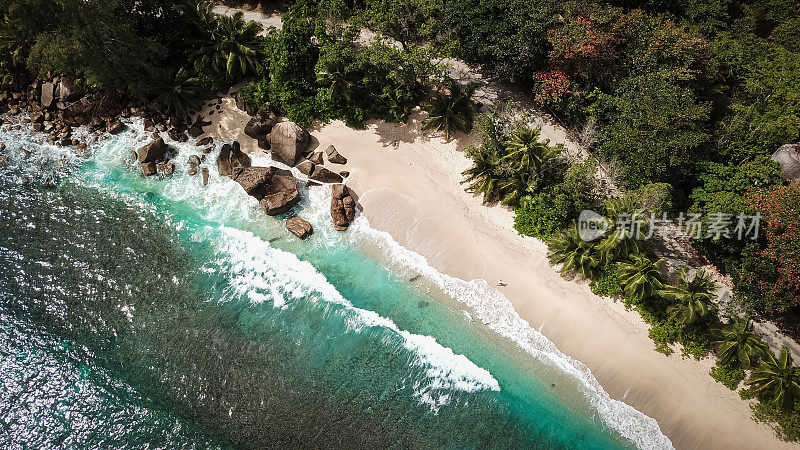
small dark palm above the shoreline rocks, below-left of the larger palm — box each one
[152,68,200,120]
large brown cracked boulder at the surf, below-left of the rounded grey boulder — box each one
[236,167,300,216]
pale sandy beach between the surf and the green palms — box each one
[206,93,793,449]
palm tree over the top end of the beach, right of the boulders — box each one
[422,83,475,141]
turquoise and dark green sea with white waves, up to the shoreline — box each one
[0,121,669,448]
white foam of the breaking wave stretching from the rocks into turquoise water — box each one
[79,119,500,412]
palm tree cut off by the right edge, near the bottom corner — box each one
[747,347,800,407]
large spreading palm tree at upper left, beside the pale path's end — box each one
[194,11,261,80]
